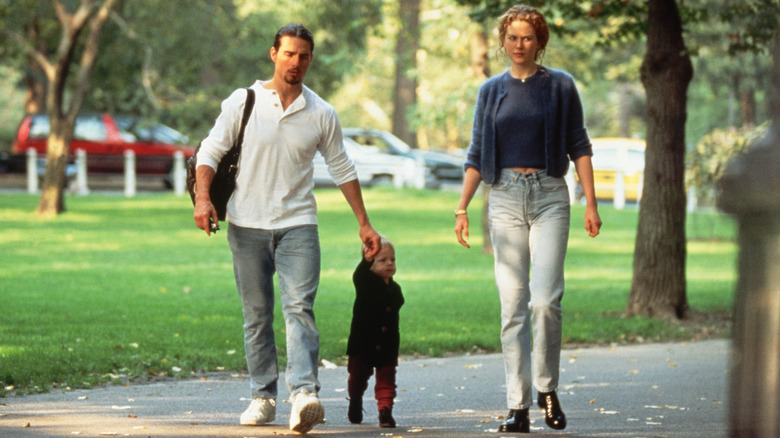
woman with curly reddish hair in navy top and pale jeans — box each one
[455,5,601,432]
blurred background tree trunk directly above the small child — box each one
[393,0,420,149]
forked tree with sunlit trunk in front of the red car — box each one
[0,0,116,216]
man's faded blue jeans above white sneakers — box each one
[228,224,320,399]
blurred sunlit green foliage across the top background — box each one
[0,0,778,202]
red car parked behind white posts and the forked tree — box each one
[13,114,195,175]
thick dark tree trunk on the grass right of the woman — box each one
[626,0,693,319]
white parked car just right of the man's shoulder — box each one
[314,137,425,187]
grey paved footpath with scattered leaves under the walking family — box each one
[0,340,730,438]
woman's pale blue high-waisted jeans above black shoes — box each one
[489,169,570,409]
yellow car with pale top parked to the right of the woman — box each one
[591,137,645,202]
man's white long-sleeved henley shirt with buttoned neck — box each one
[198,81,357,229]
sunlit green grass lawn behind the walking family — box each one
[0,188,737,396]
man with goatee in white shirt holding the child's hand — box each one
[194,24,380,433]
